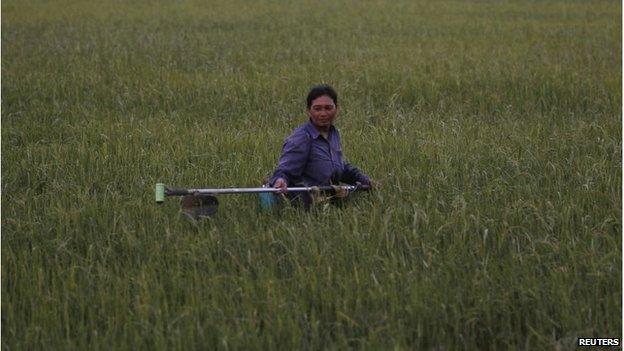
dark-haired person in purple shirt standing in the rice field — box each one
[269,85,371,207]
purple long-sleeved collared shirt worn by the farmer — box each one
[270,121,370,186]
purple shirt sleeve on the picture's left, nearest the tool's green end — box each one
[269,133,311,186]
